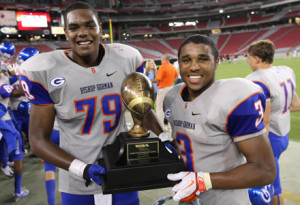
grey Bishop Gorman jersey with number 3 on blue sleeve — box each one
[164,78,266,205]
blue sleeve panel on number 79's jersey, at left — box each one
[20,74,54,105]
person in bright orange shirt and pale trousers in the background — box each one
[151,54,178,129]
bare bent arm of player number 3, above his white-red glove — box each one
[210,134,276,189]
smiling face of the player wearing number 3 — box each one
[179,42,219,101]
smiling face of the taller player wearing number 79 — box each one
[65,9,101,66]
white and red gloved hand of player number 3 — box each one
[167,172,212,203]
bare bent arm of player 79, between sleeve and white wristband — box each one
[29,105,74,170]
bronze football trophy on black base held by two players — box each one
[100,72,185,194]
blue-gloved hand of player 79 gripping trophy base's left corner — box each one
[83,164,106,186]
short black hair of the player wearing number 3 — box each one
[178,34,219,61]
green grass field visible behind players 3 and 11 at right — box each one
[216,58,300,141]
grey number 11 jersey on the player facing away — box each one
[246,66,296,136]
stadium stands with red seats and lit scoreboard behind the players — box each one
[0,0,300,62]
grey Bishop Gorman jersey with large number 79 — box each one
[20,44,143,194]
